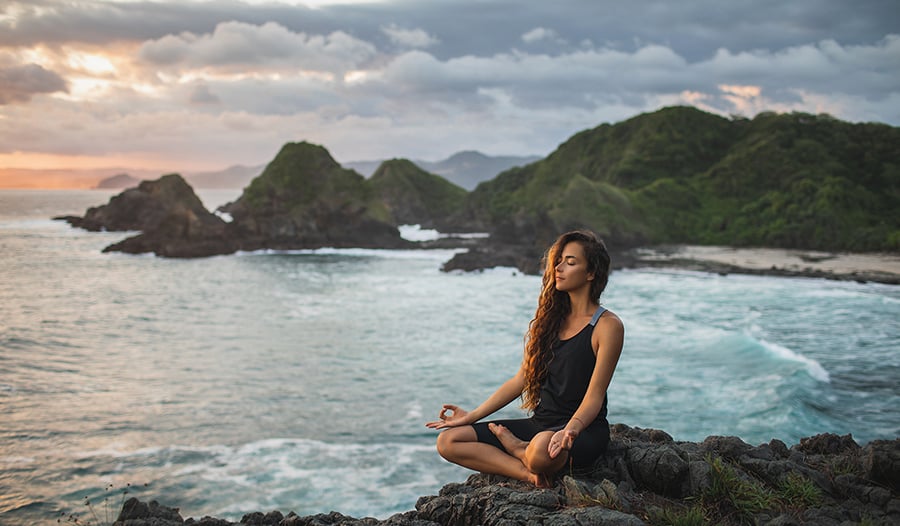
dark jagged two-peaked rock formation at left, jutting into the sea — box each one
[57,143,411,257]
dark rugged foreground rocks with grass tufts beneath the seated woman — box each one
[95,424,900,526]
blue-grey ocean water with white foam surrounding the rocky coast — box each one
[0,190,900,524]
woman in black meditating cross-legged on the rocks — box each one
[425,231,625,487]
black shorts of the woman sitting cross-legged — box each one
[472,418,609,472]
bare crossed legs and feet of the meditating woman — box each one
[437,424,568,487]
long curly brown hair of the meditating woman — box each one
[522,230,610,410]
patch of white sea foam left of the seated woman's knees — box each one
[142,439,447,515]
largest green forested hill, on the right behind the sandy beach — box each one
[466,107,900,251]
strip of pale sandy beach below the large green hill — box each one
[630,245,900,284]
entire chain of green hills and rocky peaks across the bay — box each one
[56,107,900,284]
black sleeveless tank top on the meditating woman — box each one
[534,307,607,427]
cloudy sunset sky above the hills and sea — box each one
[0,0,900,177]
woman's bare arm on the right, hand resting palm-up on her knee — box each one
[549,312,625,458]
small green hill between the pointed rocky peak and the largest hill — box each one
[366,159,467,230]
